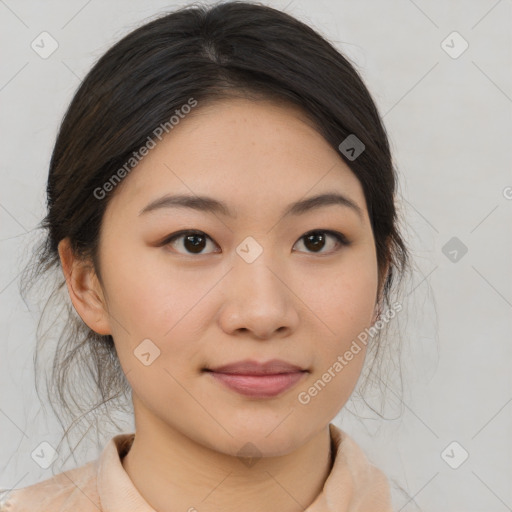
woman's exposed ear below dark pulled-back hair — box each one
[58,238,111,335]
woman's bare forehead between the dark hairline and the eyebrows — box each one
[109,98,365,223]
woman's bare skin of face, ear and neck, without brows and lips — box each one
[59,99,379,512]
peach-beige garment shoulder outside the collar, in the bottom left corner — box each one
[0,460,101,512]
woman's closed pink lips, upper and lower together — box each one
[204,359,307,398]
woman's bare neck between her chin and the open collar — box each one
[122,412,334,512]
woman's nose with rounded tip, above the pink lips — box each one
[219,251,300,340]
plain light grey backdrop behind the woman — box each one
[0,0,512,512]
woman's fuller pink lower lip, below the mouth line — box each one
[208,372,307,398]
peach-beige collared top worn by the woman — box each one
[0,423,393,512]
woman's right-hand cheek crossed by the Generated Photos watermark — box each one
[299,251,378,406]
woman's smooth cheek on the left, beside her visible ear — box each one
[105,252,218,392]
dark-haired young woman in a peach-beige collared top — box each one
[2,2,408,512]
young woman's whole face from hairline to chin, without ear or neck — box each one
[99,99,378,456]
